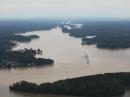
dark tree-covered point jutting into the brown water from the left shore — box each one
[0,49,54,68]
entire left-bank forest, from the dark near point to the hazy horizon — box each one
[0,20,56,68]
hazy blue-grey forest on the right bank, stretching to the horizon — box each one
[61,20,130,49]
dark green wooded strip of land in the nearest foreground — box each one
[9,73,130,97]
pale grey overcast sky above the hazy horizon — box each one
[0,0,130,18]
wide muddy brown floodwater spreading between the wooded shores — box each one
[0,27,130,97]
